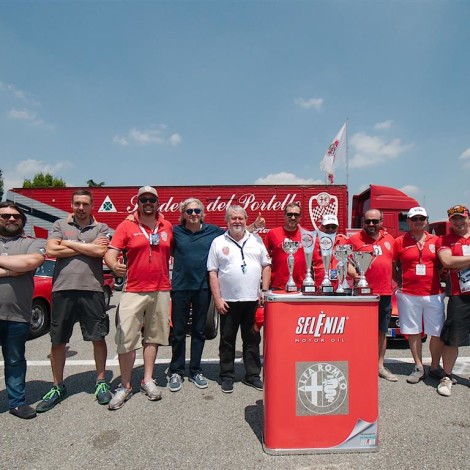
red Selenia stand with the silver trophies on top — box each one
[263,229,379,454]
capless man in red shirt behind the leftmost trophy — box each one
[264,202,307,290]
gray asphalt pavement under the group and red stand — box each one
[0,293,470,470]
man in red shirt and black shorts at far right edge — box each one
[437,204,470,397]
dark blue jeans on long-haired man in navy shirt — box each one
[170,289,210,376]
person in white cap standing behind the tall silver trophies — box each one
[312,214,347,292]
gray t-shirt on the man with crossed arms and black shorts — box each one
[48,219,109,292]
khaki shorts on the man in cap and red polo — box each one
[115,291,170,354]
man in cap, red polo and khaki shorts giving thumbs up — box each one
[105,186,173,410]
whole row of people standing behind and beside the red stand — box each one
[0,186,470,419]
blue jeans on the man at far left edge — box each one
[0,320,29,409]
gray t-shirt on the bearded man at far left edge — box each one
[0,235,45,323]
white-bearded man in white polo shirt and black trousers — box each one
[207,206,271,393]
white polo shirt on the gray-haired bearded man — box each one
[207,232,271,302]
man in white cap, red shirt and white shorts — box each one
[393,207,445,384]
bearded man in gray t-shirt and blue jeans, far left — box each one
[0,202,45,419]
